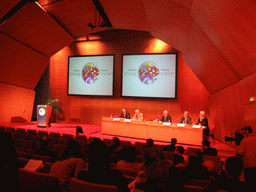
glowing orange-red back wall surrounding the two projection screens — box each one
[49,30,210,124]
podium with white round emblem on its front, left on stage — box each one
[37,105,52,127]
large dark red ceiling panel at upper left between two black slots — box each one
[0,3,74,57]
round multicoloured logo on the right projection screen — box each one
[139,61,159,85]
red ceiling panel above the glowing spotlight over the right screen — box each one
[144,0,193,51]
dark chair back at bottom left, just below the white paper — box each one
[18,168,61,192]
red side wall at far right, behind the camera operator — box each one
[209,73,256,141]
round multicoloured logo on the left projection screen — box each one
[82,63,100,84]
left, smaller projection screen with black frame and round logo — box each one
[67,55,114,97]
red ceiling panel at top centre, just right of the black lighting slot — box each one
[100,0,149,31]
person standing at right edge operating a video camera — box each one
[236,126,256,184]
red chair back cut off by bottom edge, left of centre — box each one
[69,178,118,192]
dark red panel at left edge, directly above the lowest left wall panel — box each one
[0,33,49,89]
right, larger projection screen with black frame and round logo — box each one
[121,53,177,99]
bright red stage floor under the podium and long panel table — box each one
[0,122,236,160]
